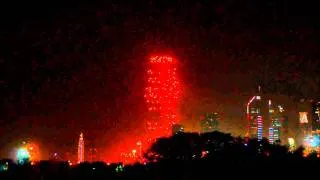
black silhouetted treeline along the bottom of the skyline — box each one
[0,132,320,180]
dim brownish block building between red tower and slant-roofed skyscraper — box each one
[200,113,220,133]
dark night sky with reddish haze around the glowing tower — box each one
[0,0,320,159]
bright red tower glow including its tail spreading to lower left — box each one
[108,56,182,164]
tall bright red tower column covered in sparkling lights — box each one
[144,56,182,139]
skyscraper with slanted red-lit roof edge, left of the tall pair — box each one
[247,96,263,141]
